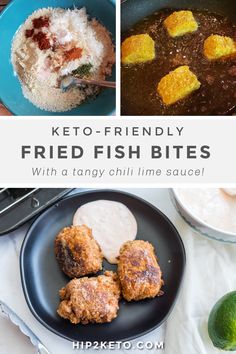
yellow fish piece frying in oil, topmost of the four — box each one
[164,11,198,37]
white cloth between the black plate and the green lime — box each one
[165,221,236,354]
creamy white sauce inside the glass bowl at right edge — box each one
[175,188,236,236]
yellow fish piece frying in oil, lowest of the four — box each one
[157,65,201,105]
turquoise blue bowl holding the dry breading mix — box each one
[0,0,116,116]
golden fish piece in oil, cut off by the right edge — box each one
[204,34,236,60]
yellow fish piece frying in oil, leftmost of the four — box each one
[121,34,155,64]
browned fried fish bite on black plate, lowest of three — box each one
[57,272,120,324]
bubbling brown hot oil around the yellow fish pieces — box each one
[121,9,236,115]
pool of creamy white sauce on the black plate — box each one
[73,200,137,263]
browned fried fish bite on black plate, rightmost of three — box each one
[118,240,163,301]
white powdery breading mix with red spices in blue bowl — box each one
[11,8,115,112]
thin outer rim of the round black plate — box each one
[19,189,186,343]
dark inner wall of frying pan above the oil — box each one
[121,0,236,32]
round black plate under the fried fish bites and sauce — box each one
[20,190,185,341]
